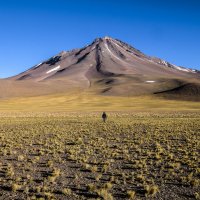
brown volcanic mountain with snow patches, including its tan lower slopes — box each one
[1,37,200,99]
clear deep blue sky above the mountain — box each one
[0,0,200,78]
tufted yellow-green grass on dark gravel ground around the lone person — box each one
[0,112,200,200]
